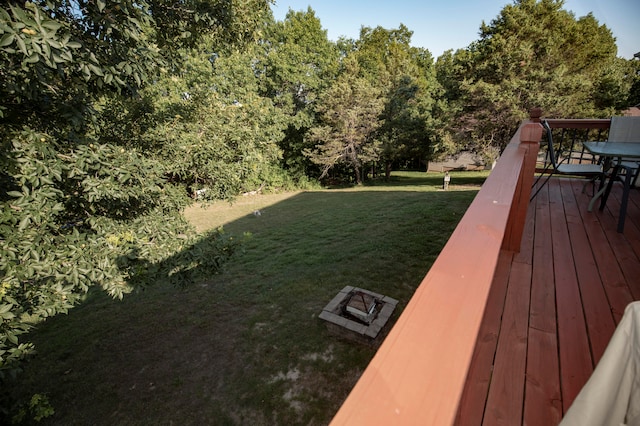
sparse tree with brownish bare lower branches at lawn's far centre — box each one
[305,57,383,184]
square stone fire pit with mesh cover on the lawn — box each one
[320,286,398,345]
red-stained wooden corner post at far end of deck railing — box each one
[502,108,543,252]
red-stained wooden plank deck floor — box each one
[456,178,640,426]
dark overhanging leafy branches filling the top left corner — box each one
[0,0,269,131]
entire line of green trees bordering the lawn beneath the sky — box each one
[0,0,640,420]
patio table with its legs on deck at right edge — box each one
[583,141,640,232]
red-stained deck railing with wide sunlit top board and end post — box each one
[332,112,542,425]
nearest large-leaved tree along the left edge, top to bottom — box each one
[0,0,270,420]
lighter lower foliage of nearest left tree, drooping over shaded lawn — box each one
[0,126,241,378]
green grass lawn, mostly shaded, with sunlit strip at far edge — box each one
[10,172,487,425]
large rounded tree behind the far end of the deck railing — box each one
[440,0,617,152]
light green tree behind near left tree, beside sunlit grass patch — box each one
[96,42,288,199]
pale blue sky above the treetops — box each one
[272,0,640,59]
